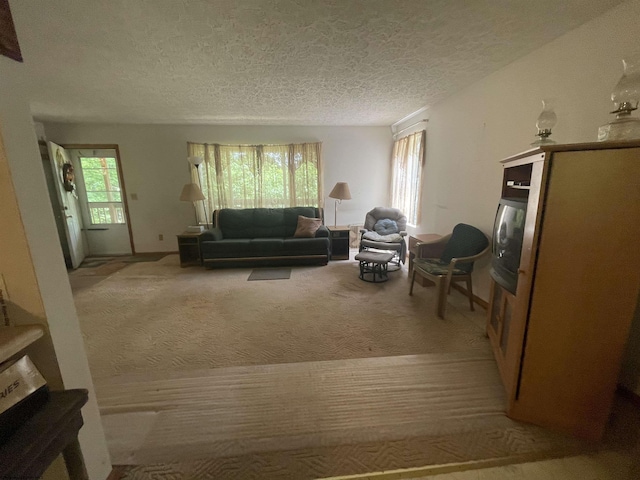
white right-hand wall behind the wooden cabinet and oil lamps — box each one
[398,0,640,398]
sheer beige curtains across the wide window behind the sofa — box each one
[187,142,323,223]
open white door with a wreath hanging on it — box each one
[49,142,87,268]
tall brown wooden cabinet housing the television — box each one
[487,142,640,439]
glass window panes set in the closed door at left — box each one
[80,157,125,225]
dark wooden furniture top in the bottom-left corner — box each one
[0,389,88,478]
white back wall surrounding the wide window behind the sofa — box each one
[45,123,392,252]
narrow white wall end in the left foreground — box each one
[0,57,111,480]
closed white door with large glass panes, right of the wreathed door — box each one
[69,148,132,255]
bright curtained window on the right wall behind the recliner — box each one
[391,130,426,225]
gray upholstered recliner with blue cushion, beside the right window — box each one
[360,207,407,267]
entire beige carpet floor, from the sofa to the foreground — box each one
[70,255,582,480]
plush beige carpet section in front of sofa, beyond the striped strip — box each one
[75,255,488,378]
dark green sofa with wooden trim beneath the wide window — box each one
[200,207,330,268]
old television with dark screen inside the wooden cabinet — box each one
[491,198,527,294]
